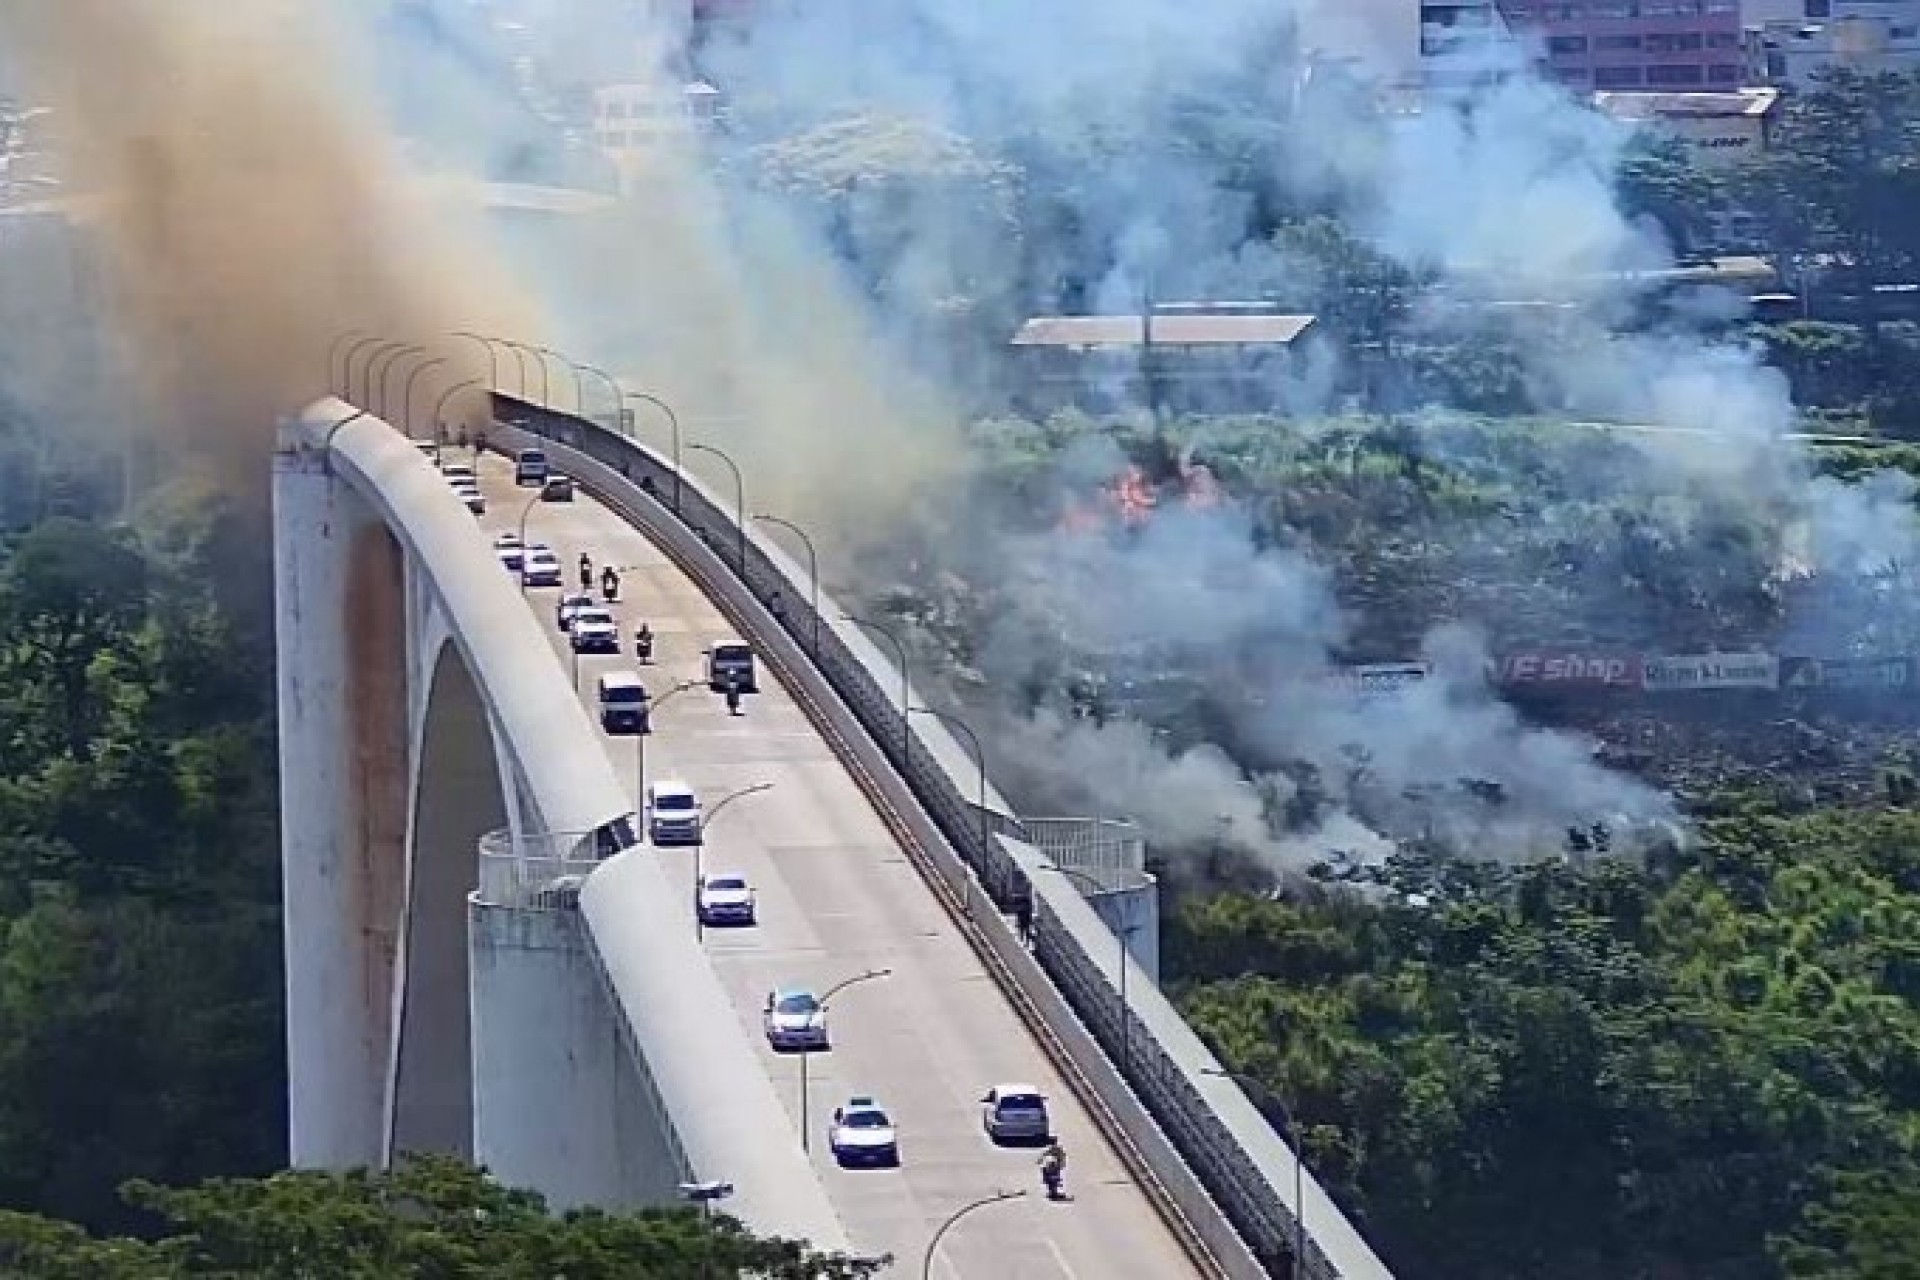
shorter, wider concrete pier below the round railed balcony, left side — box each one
[467,900,684,1209]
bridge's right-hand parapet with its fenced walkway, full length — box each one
[488,397,1388,1280]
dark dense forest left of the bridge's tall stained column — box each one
[0,495,284,1230]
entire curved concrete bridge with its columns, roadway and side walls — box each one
[275,395,1386,1280]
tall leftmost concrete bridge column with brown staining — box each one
[273,453,407,1169]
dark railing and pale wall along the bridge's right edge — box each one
[490,395,1390,1280]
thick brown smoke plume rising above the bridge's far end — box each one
[0,0,526,479]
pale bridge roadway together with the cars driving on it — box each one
[456,449,1194,1280]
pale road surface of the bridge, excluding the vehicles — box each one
[480,457,1194,1280]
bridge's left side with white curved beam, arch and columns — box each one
[273,399,847,1249]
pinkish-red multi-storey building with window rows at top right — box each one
[1498,0,1747,90]
